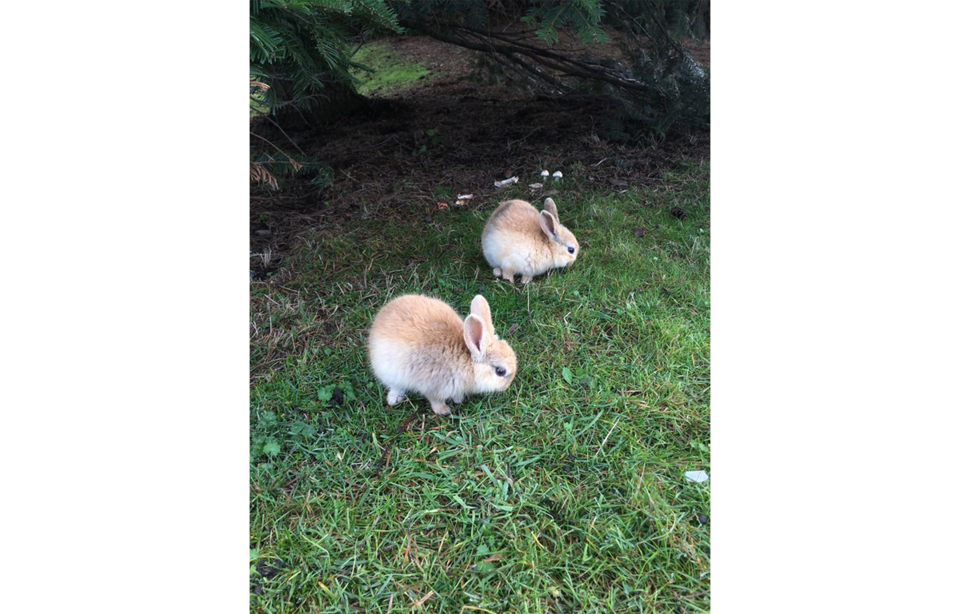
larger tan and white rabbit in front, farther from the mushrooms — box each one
[369,294,517,416]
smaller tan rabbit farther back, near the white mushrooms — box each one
[480,198,580,284]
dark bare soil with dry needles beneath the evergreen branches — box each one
[249,36,711,279]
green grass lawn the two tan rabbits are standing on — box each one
[249,163,712,613]
